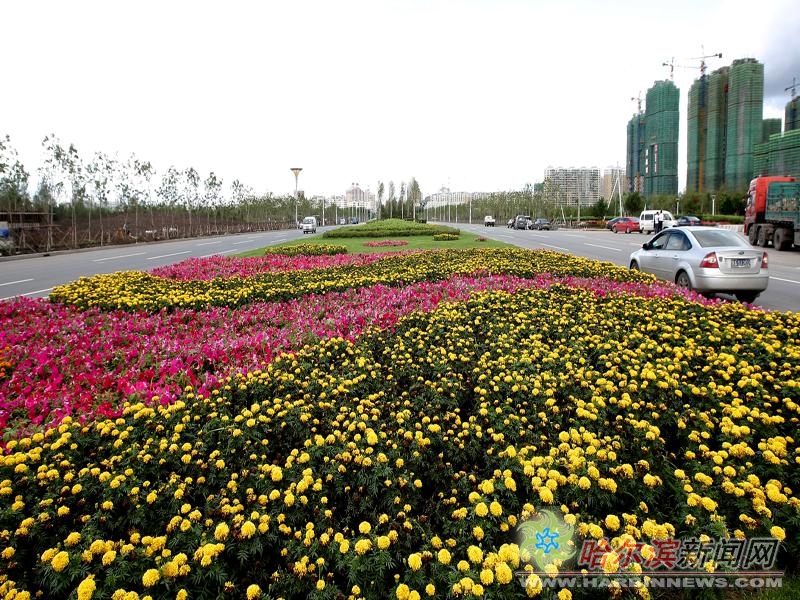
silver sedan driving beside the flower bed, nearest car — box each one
[628,226,769,302]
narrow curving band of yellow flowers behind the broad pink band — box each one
[50,248,655,311]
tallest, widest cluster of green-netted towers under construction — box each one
[686,58,774,192]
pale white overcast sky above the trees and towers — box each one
[0,0,800,195]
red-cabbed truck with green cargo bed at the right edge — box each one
[744,176,800,250]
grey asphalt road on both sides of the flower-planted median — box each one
[0,224,800,312]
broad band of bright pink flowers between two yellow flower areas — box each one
[0,274,710,434]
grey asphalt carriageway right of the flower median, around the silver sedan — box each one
[458,224,800,312]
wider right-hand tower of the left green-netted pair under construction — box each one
[643,81,680,197]
